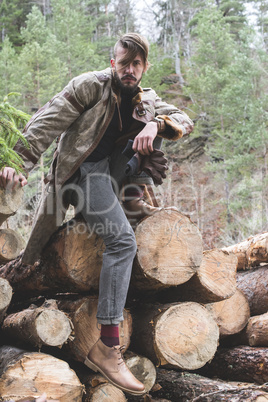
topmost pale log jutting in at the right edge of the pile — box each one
[223,232,268,270]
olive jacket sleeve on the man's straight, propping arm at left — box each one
[14,74,100,174]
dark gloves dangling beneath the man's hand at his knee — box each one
[122,140,168,184]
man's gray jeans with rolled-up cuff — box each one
[68,139,161,325]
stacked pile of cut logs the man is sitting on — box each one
[0,210,268,402]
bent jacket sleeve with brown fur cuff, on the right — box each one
[155,95,194,141]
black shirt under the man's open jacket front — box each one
[86,95,133,162]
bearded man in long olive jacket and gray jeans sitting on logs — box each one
[0,33,193,395]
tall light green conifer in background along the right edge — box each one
[186,5,268,236]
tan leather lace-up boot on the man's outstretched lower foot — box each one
[84,339,145,395]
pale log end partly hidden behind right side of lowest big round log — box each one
[205,289,250,337]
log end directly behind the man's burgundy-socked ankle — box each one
[58,296,132,362]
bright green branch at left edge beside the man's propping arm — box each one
[0,93,29,172]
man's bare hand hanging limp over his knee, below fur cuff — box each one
[132,121,157,155]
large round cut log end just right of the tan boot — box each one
[155,302,219,370]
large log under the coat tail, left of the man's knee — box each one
[0,221,104,298]
